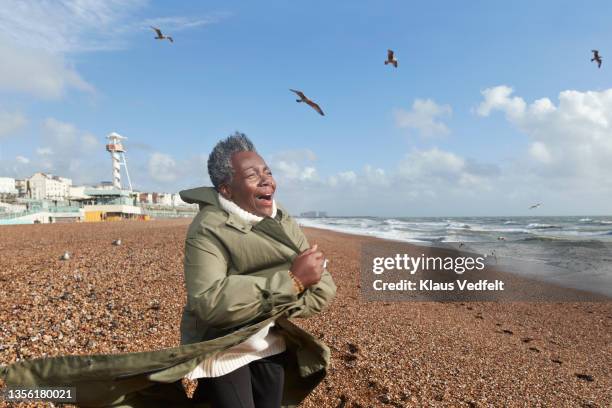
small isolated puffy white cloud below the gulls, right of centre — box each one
[394,99,452,136]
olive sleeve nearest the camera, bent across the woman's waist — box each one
[185,235,298,329]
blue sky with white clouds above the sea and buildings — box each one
[0,0,612,217]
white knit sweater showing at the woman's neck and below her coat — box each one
[185,194,286,380]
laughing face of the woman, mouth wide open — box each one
[219,152,276,217]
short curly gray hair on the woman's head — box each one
[208,132,257,190]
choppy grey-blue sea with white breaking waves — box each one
[297,216,612,297]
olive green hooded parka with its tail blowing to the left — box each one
[0,187,336,408]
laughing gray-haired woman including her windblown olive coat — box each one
[0,134,336,408]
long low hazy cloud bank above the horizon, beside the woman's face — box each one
[268,144,502,215]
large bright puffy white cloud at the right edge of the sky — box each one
[478,85,612,188]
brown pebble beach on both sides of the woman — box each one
[0,220,612,408]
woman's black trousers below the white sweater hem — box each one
[193,352,287,408]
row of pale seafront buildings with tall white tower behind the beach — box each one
[0,132,197,225]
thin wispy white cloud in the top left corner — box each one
[0,0,226,99]
